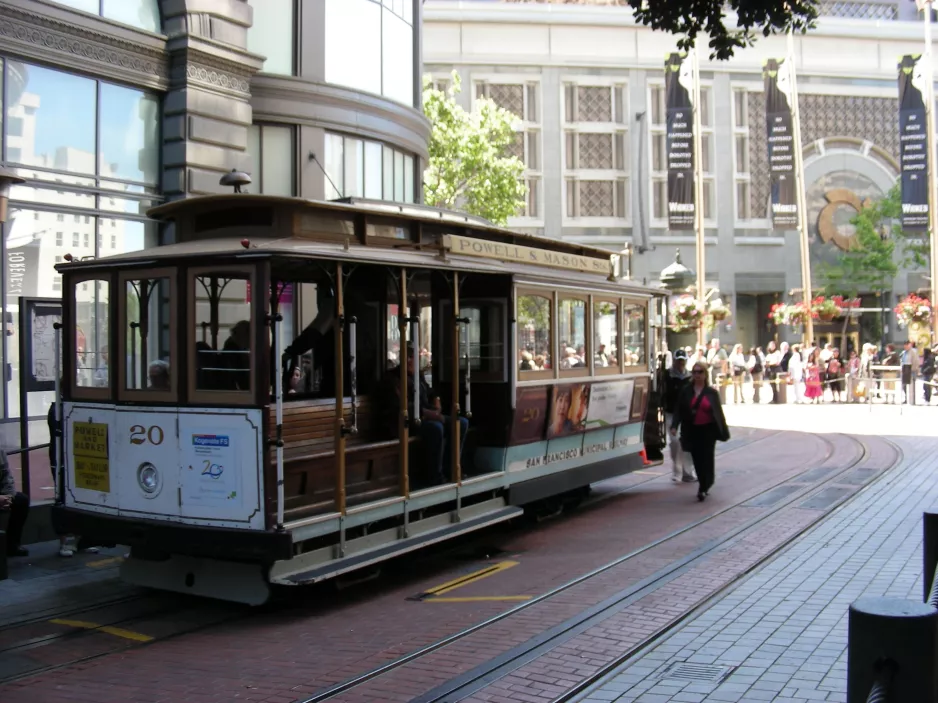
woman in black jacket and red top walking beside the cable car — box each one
[671,361,730,501]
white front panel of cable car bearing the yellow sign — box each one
[62,403,120,514]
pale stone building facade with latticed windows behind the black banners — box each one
[424,0,928,345]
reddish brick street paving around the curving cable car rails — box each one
[0,407,914,703]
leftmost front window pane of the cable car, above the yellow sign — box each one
[72,279,111,388]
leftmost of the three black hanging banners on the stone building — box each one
[664,53,695,230]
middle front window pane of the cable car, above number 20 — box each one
[121,273,178,393]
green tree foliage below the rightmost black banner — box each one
[818,184,928,297]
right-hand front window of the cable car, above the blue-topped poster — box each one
[191,270,254,393]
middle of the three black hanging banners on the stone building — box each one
[762,59,798,229]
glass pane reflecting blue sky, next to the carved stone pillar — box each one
[98,83,160,184]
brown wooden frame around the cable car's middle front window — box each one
[117,267,183,403]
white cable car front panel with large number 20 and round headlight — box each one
[115,407,179,521]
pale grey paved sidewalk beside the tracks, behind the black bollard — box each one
[578,438,938,703]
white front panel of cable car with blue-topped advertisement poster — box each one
[179,409,264,529]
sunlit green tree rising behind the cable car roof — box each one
[423,71,527,225]
